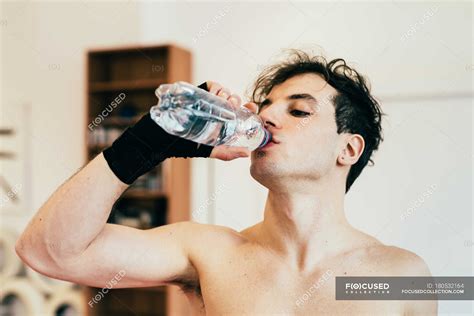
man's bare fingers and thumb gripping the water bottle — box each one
[202,81,258,161]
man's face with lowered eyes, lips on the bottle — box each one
[250,74,343,187]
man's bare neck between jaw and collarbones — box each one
[261,178,354,270]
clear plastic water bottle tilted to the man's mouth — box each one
[150,81,271,150]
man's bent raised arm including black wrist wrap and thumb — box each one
[16,81,254,287]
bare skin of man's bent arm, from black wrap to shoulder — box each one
[16,154,200,287]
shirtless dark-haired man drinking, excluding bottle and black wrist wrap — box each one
[16,52,437,315]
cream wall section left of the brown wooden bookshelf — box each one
[0,2,139,230]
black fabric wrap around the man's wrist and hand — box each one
[103,83,214,184]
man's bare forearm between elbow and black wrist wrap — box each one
[17,153,128,261]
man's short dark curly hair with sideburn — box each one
[250,49,385,193]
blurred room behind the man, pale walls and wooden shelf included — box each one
[0,1,474,315]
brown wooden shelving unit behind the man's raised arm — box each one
[84,45,192,316]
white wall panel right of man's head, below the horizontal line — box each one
[346,97,473,314]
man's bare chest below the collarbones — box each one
[184,251,403,315]
